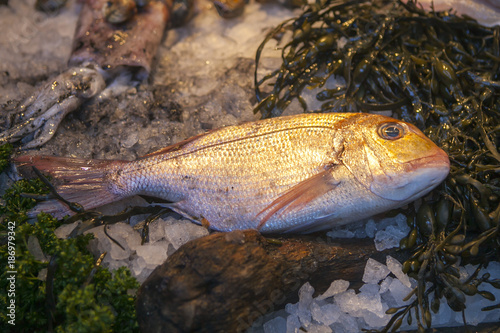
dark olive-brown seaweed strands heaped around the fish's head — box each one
[254,0,500,332]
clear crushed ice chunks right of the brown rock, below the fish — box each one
[252,256,500,333]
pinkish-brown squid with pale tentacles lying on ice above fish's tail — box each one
[0,0,170,148]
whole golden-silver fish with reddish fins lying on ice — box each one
[16,113,450,232]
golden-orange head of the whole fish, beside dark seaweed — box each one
[342,115,450,203]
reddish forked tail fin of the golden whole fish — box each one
[14,156,127,219]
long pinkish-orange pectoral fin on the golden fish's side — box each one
[257,166,340,230]
